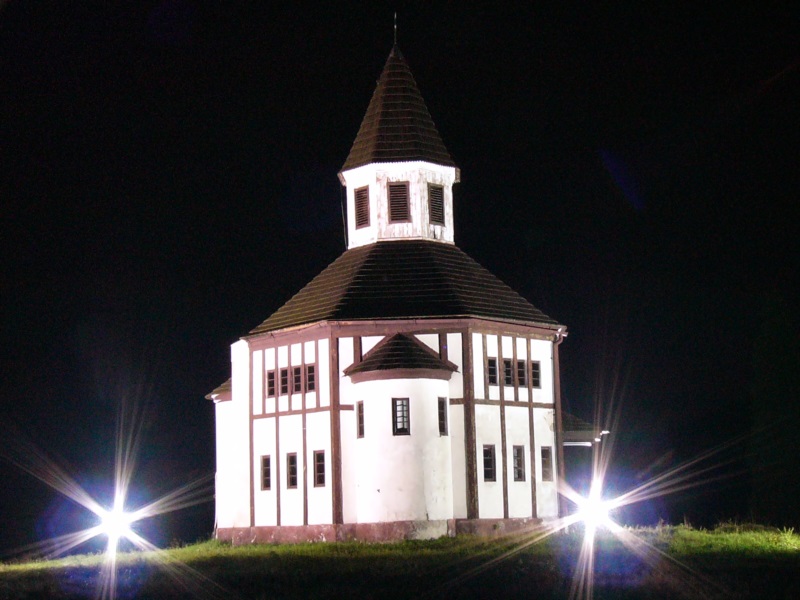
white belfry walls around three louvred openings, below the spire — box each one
[341,161,456,248]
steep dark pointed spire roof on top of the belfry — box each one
[342,45,456,171]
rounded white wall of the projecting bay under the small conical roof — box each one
[343,379,453,523]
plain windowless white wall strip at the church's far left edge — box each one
[215,340,250,527]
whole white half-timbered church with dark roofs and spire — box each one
[207,45,566,543]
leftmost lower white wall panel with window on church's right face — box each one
[475,404,504,519]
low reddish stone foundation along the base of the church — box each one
[216,518,542,546]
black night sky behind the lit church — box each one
[0,0,800,547]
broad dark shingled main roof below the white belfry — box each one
[250,240,558,335]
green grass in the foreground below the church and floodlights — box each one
[0,523,800,600]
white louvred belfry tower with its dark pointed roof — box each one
[339,45,460,248]
